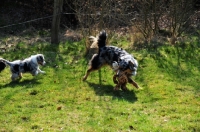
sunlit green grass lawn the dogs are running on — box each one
[0,35,200,132]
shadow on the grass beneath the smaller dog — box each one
[0,78,40,89]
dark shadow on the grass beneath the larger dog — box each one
[86,81,137,103]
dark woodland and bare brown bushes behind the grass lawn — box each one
[0,0,200,43]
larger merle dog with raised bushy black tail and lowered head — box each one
[83,31,139,88]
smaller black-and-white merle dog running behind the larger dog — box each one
[0,54,46,81]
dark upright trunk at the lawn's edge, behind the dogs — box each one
[51,0,63,44]
